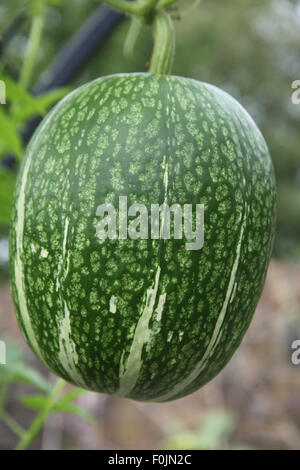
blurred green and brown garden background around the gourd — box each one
[0,0,300,449]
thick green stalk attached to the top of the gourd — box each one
[149,11,175,74]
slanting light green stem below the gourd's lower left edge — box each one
[16,379,66,450]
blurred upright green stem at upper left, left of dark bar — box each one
[20,5,44,89]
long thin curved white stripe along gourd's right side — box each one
[155,207,247,401]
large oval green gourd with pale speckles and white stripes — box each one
[10,74,275,401]
